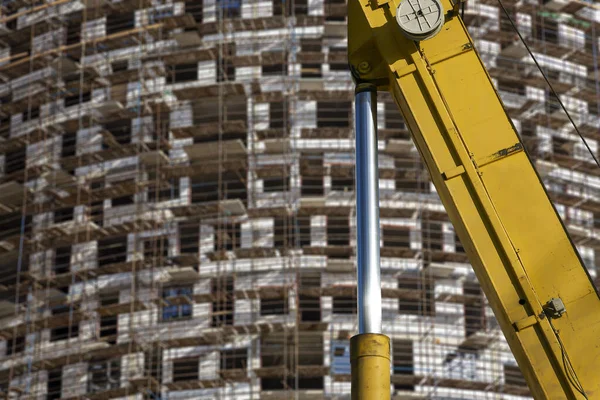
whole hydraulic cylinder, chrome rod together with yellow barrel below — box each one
[350,84,390,400]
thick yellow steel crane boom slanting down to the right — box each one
[348,0,600,399]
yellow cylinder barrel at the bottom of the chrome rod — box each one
[350,333,390,400]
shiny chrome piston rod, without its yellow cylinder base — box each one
[355,87,381,333]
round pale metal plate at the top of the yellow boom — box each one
[396,0,444,40]
